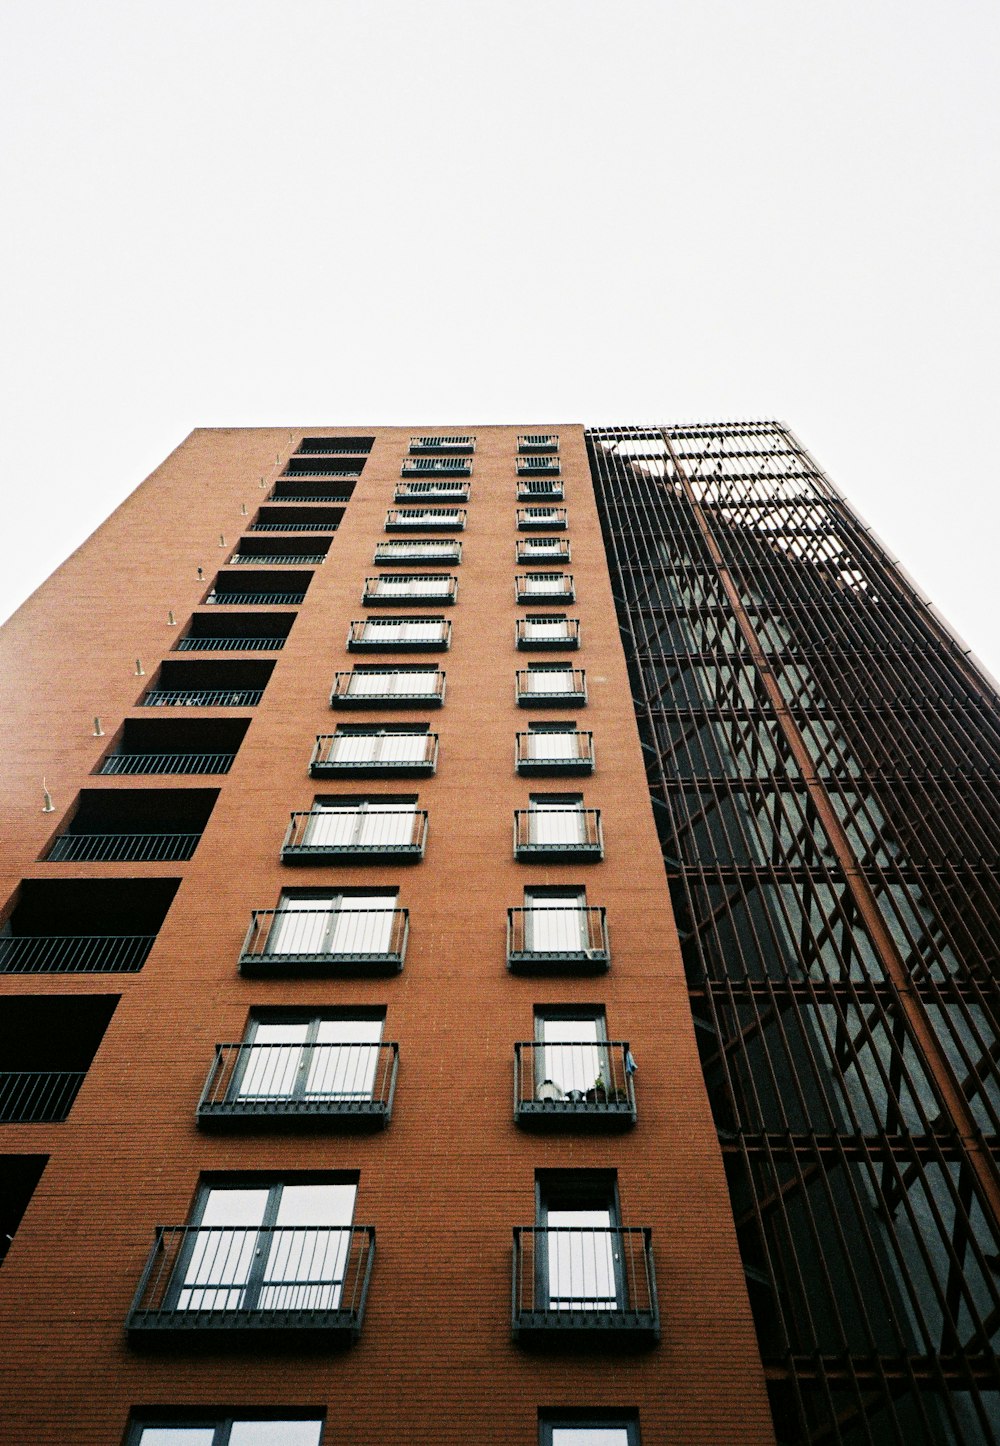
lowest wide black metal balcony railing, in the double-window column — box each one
[126,1225,374,1345]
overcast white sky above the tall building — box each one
[0,0,1000,672]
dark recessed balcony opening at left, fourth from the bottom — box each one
[45,788,218,863]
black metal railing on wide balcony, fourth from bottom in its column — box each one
[282,805,428,863]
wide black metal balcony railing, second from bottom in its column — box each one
[197,1043,399,1129]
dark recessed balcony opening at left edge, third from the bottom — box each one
[0,879,181,975]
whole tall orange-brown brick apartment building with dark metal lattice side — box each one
[0,424,1000,1446]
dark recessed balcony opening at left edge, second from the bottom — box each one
[0,995,121,1125]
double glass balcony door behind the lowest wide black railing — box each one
[171,1183,357,1312]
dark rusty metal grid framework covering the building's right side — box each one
[588,422,1000,1446]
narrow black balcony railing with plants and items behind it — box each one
[514,1040,636,1129]
